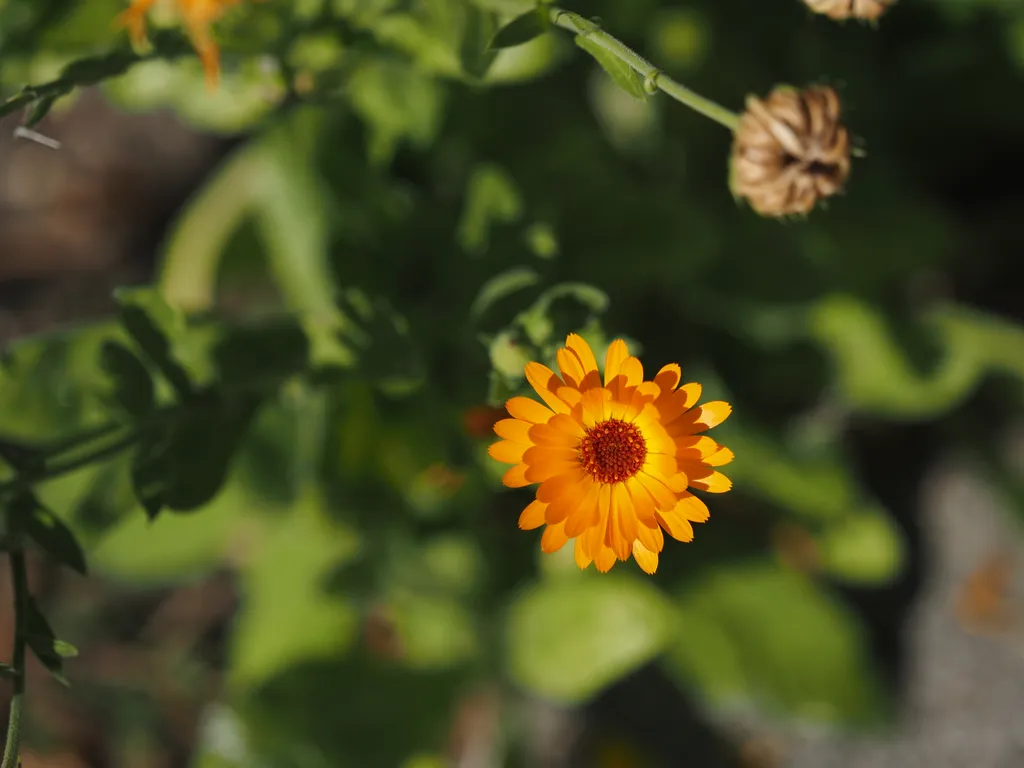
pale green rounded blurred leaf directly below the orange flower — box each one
[505,574,673,703]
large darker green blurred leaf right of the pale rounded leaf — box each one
[668,561,884,723]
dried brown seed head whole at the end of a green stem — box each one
[730,86,850,216]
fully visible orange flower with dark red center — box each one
[489,334,732,573]
